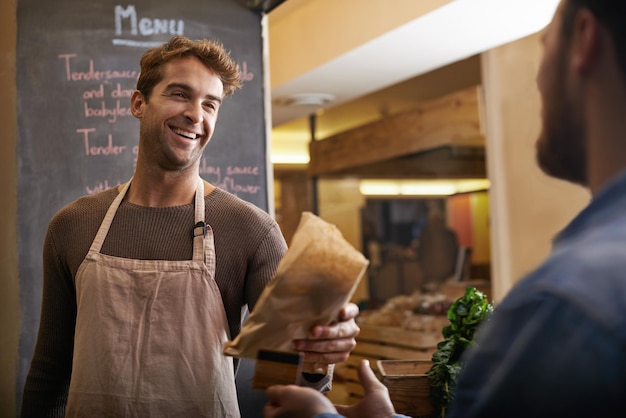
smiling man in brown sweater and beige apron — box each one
[22,37,358,418]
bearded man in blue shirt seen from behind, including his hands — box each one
[266,0,626,418]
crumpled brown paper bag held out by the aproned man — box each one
[224,212,369,373]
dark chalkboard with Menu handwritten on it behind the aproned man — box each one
[16,0,268,412]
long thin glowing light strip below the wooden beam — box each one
[359,179,489,196]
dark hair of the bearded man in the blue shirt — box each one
[562,0,626,78]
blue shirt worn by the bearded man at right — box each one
[448,174,626,418]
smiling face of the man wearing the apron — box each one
[131,57,223,171]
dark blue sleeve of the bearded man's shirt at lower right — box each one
[448,290,626,418]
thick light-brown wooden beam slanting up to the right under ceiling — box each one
[309,86,485,176]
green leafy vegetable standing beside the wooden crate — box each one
[427,287,493,418]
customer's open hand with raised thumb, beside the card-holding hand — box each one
[335,360,395,418]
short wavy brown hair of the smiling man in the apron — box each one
[137,36,241,100]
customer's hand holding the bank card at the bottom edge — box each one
[263,385,337,418]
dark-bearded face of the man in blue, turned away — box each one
[536,0,587,185]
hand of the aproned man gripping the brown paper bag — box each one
[294,303,360,374]
